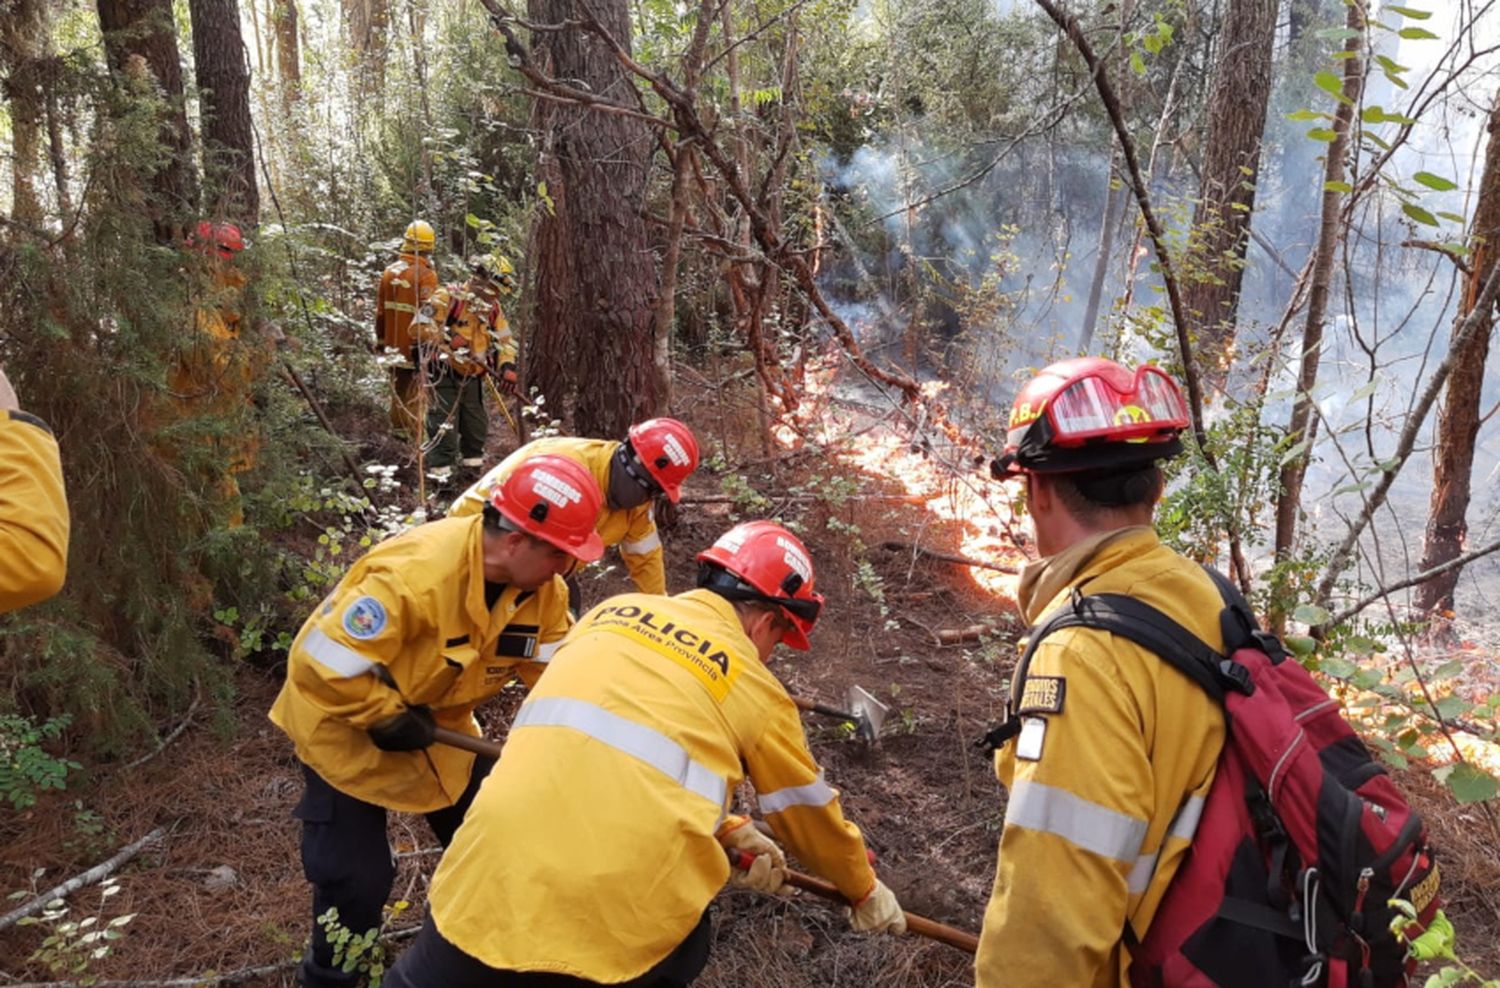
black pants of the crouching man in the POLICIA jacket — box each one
[383,909,713,988]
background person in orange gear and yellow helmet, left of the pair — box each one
[375,219,438,439]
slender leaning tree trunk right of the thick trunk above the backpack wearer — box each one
[1271,0,1365,633]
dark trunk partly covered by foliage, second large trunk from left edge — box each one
[98,0,198,241]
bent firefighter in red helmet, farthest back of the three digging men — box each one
[449,418,698,602]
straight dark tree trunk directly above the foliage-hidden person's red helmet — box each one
[189,0,261,226]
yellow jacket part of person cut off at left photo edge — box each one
[0,412,68,613]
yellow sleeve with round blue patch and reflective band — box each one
[287,573,435,730]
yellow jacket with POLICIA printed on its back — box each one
[428,591,875,984]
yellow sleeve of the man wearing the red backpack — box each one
[975,631,1154,988]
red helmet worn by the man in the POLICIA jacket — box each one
[698,522,824,652]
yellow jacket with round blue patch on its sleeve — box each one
[270,517,570,813]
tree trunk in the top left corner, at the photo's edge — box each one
[0,0,50,226]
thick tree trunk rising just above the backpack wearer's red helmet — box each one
[1182,0,1278,381]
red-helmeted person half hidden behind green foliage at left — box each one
[164,220,270,526]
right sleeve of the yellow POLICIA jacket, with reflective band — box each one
[746,697,875,901]
